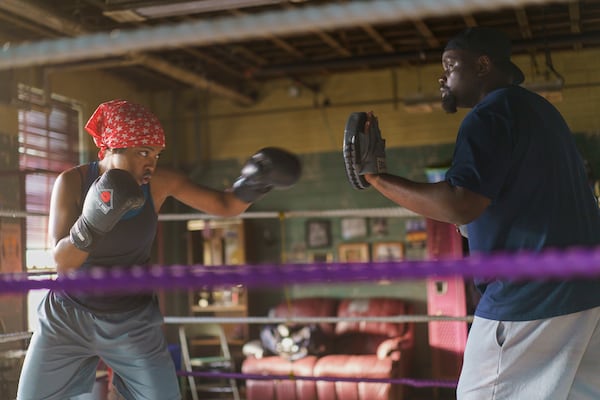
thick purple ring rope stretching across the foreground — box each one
[0,247,600,293]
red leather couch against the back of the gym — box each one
[242,297,414,400]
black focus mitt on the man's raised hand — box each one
[343,112,387,190]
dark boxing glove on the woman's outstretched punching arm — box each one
[233,147,302,203]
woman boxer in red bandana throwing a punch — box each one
[17,100,300,400]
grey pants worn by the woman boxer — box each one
[17,292,181,400]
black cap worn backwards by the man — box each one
[444,26,525,85]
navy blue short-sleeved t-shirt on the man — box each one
[446,86,600,321]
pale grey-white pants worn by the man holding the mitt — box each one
[457,307,600,400]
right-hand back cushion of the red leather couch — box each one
[335,297,407,337]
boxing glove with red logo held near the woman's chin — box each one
[69,169,145,252]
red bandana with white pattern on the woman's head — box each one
[85,100,165,160]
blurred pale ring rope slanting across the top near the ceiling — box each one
[0,0,567,70]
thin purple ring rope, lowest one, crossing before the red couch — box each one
[177,371,457,388]
